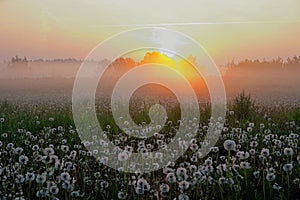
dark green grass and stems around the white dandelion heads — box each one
[0,100,300,199]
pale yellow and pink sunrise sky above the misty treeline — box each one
[0,0,300,64]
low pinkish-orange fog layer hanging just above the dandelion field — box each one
[0,61,300,104]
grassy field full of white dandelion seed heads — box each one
[0,96,300,200]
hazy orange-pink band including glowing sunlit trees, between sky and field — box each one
[0,52,300,103]
